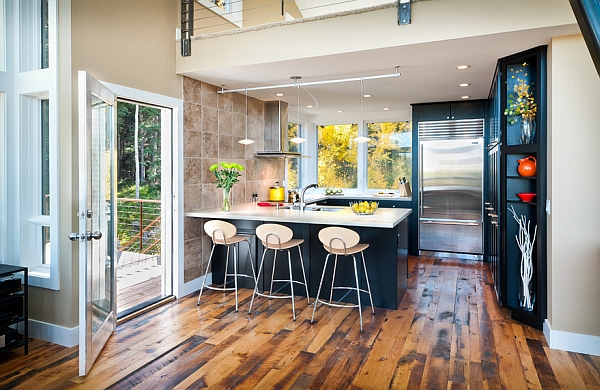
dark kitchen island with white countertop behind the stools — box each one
[186,203,411,309]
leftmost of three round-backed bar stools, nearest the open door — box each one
[198,220,256,311]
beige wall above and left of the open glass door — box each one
[29,0,182,329]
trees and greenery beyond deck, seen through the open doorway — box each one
[117,101,161,254]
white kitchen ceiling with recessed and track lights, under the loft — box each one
[186,6,578,119]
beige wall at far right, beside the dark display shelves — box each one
[548,35,600,336]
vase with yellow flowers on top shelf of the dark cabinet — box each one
[504,64,537,144]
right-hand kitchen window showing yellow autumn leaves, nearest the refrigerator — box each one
[367,121,412,189]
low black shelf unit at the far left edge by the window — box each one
[0,264,29,355]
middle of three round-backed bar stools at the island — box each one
[248,223,310,321]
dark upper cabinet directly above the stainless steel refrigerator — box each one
[413,100,485,122]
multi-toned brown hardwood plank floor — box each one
[0,256,600,390]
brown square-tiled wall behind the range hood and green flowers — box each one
[183,77,285,283]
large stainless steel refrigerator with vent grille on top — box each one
[418,119,484,254]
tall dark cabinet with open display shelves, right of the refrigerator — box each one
[486,46,547,329]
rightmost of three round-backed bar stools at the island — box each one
[310,226,375,332]
